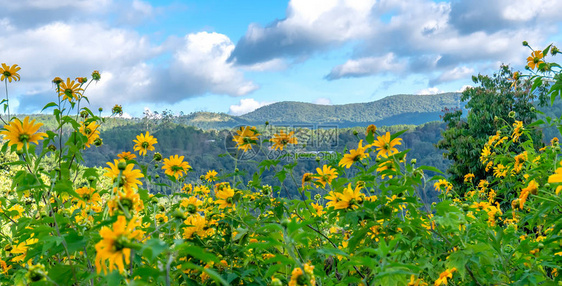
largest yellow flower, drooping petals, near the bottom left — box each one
[95,216,142,274]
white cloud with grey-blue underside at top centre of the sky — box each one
[228,0,375,65]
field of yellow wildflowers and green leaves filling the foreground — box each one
[0,43,562,286]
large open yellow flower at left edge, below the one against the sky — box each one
[0,116,47,150]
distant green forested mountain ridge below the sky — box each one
[177,92,464,129]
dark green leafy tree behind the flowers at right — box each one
[437,65,546,193]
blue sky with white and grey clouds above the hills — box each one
[0,0,562,116]
